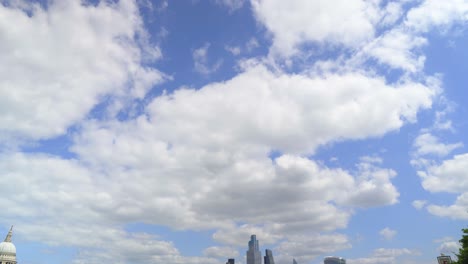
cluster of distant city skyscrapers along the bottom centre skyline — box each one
[226,235,346,264]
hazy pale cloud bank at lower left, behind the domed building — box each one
[0,153,221,263]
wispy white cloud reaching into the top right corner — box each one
[362,0,468,73]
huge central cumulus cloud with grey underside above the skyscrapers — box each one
[58,58,434,258]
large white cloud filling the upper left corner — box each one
[0,0,163,143]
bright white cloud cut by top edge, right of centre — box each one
[251,0,379,56]
